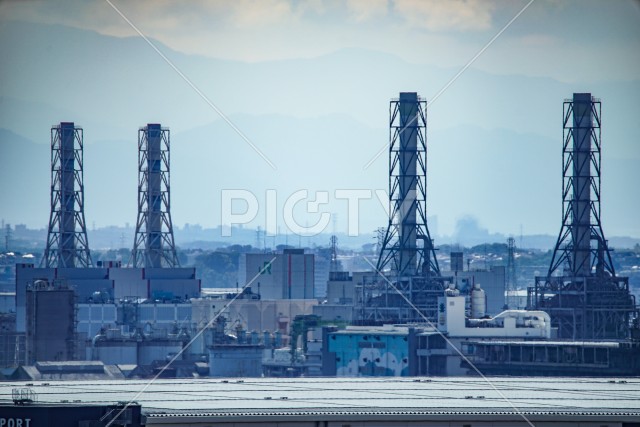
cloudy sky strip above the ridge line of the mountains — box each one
[5,0,640,81]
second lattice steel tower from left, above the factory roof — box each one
[130,124,180,268]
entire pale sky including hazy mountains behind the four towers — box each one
[0,0,640,243]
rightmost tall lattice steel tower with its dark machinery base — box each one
[528,93,636,339]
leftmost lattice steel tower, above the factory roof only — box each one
[42,122,93,268]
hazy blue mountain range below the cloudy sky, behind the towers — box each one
[0,22,640,238]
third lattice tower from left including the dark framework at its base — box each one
[355,92,444,324]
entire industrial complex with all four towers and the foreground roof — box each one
[0,92,640,427]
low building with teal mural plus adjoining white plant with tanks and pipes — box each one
[322,285,553,377]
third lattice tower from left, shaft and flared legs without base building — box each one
[376,92,440,277]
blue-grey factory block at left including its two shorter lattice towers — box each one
[3,122,208,369]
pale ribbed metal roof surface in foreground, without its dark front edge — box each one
[0,377,640,416]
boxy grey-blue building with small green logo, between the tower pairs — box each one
[238,249,315,300]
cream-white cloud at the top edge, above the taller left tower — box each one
[394,0,494,32]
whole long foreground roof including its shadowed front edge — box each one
[0,377,640,427]
